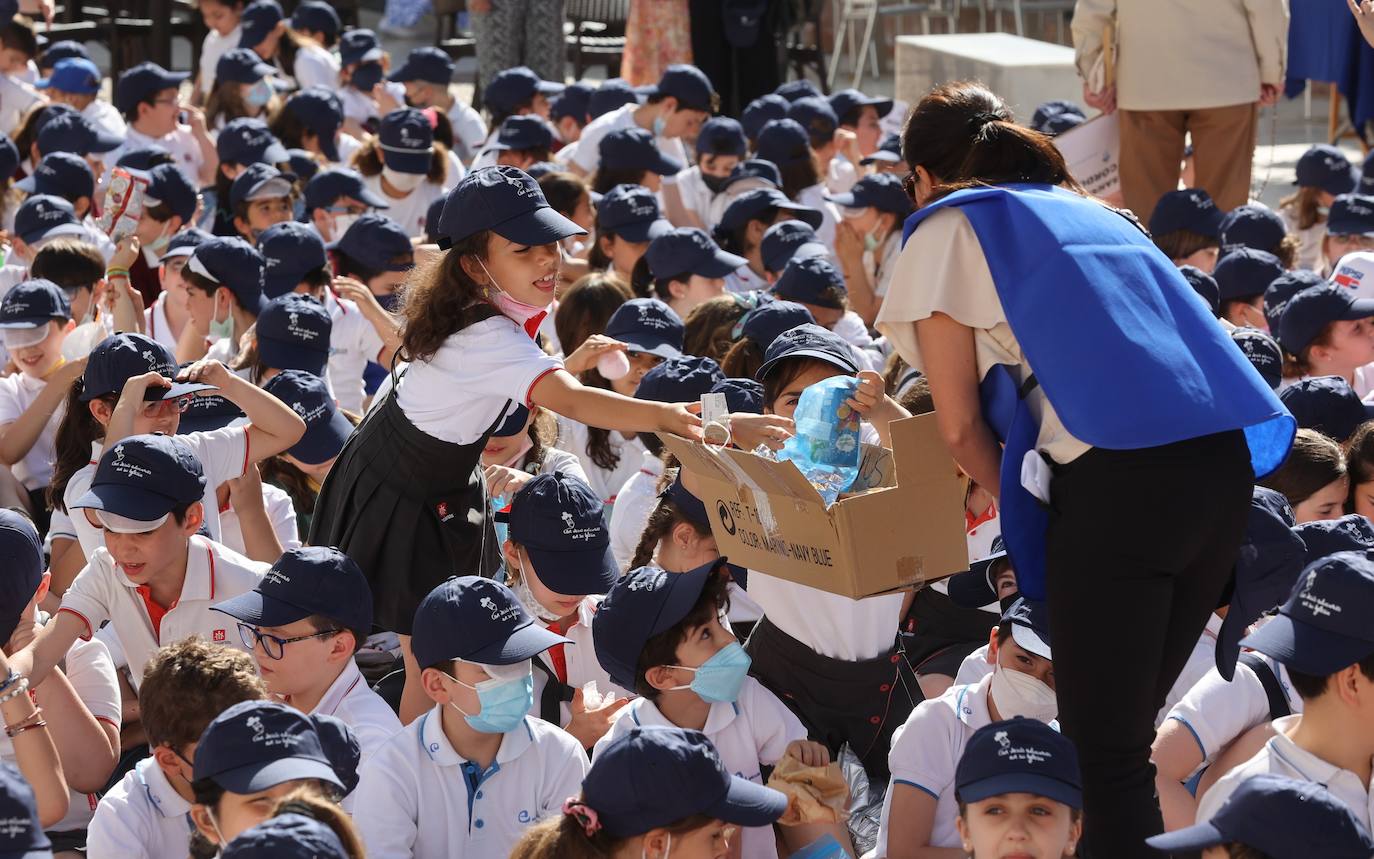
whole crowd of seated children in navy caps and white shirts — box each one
[0,0,1374,859]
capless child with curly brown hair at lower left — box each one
[87,638,267,859]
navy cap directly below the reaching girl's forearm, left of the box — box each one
[508,471,620,596]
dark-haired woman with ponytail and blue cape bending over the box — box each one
[877,82,1296,858]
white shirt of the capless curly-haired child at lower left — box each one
[87,757,195,859]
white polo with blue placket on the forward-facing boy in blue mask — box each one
[353,704,589,859]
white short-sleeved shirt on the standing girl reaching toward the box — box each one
[397,316,566,449]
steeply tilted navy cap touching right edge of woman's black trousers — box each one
[1213,487,1307,680]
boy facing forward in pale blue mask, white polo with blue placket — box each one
[354,576,588,859]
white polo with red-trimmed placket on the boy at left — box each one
[58,535,268,687]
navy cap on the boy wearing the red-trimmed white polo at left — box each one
[69,436,205,522]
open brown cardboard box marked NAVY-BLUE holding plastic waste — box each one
[660,415,969,599]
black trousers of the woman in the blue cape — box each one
[1047,432,1254,859]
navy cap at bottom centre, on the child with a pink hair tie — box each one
[581,725,787,838]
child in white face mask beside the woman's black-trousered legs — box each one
[875,601,1058,859]
